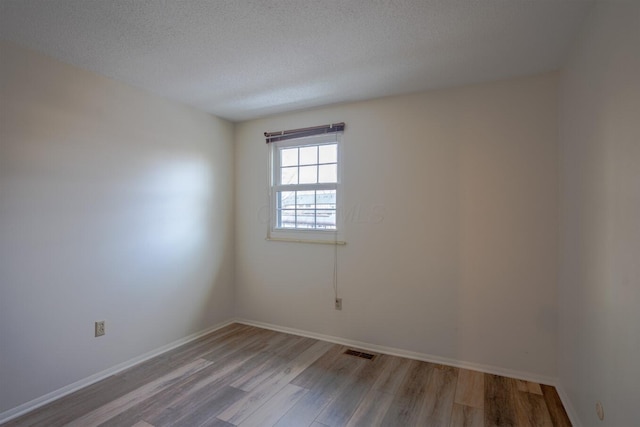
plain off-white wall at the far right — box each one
[558,2,640,426]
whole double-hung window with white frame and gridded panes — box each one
[268,127,342,243]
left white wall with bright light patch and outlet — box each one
[0,43,234,412]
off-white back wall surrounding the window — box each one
[236,73,558,377]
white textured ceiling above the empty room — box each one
[0,0,592,121]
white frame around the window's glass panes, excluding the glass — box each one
[267,132,346,244]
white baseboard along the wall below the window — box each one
[236,319,557,387]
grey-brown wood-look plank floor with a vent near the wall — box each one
[4,324,571,427]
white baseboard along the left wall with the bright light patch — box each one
[0,319,234,424]
